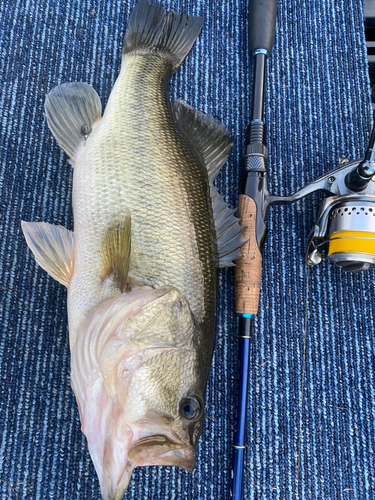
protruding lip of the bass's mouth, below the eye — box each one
[128,434,195,471]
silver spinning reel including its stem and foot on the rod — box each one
[251,117,375,272]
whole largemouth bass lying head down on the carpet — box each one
[22,0,244,500]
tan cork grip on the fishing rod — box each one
[234,194,262,314]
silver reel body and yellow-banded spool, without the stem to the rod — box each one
[306,152,375,272]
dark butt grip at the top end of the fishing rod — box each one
[248,0,277,54]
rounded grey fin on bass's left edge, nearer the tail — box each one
[44,82,102,162]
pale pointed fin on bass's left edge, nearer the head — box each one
[21,221,74,287]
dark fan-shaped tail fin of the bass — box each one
[122,0,203,71]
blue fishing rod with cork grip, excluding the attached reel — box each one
[231,0,277,500]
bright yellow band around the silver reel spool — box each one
[328,231,375,255]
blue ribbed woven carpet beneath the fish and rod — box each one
[0,0,375,500]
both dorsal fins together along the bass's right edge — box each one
[171,101,246,267]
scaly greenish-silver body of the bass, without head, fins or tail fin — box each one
[69,53,216,344]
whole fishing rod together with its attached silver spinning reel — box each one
[230,0,375,500]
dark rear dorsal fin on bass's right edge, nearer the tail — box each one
[171,100,233,182]
